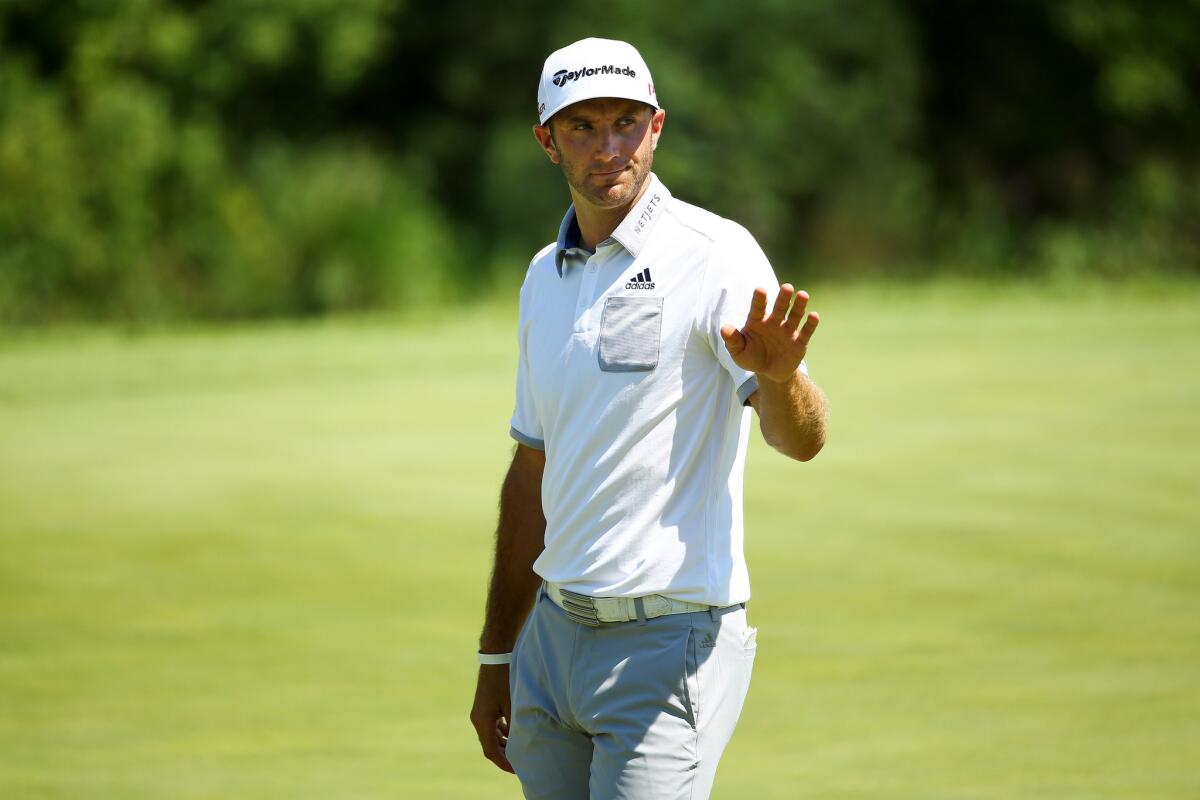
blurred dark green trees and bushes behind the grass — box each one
[0,0,1200,323]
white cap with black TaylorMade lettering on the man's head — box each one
[538,38,659,125]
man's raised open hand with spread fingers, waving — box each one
[721,283,821,383]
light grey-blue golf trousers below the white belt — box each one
[506,589,755,800]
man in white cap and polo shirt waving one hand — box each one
[470,38,826,800]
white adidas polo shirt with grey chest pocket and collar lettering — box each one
[511,175,796,606]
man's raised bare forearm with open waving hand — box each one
[721,283,828,461]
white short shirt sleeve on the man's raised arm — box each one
[702,223,806,403]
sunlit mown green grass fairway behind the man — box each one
[0,285,1200,800]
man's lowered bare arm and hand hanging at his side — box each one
[470,444,546,772]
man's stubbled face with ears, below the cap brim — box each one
[534,97,666,209]
